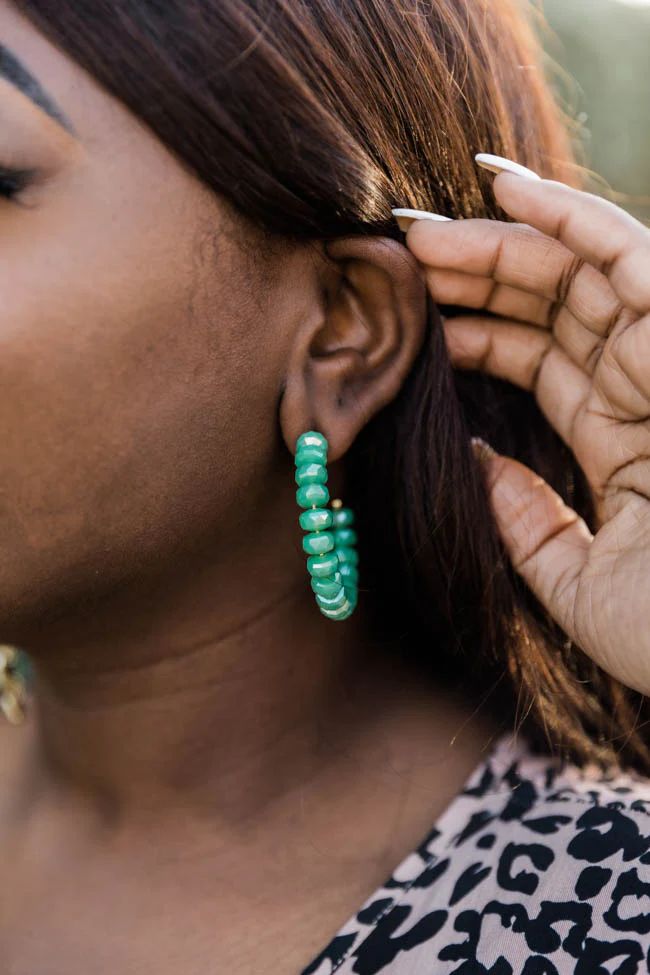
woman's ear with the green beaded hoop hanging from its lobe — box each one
[279,235,426,461]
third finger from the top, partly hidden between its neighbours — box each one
[425,268,612,376]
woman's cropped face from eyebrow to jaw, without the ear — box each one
[0,0,326,645]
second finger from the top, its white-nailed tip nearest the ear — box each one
[406,215,623,336]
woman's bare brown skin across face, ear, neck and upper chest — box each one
[0,0,497,975]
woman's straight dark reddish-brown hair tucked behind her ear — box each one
[15,0,650,771]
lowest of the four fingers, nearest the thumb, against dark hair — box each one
[443,315,592,448]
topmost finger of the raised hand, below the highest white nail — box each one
[492,172,650,314]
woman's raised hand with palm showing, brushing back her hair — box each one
[398,158,650,694]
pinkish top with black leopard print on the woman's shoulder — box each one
[301,733,650,975]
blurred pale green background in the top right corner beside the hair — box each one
[534,0,650,224]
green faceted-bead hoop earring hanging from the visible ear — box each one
[295,430,359,620]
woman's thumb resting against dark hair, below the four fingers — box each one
[472,437,593,642]
